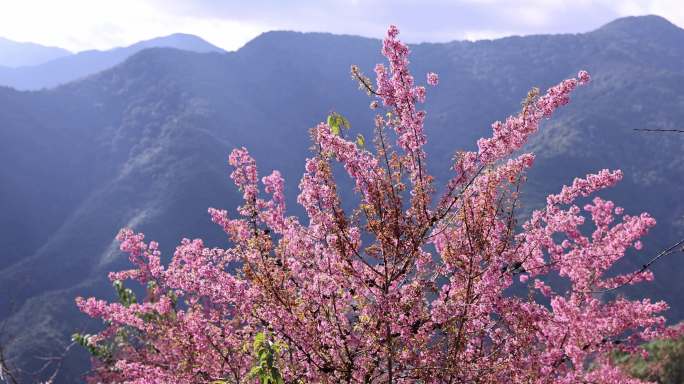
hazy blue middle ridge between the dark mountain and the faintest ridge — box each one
[0,33,223,90]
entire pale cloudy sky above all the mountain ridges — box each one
[0,0,684,52]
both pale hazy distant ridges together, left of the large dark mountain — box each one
[0,33,223,90]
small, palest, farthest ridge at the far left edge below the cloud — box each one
[0,37,72,68]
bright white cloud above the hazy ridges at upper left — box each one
[0,0,265,51]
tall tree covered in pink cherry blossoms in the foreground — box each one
[75,26,675,383]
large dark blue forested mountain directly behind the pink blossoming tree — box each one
[0,16,684,383]
